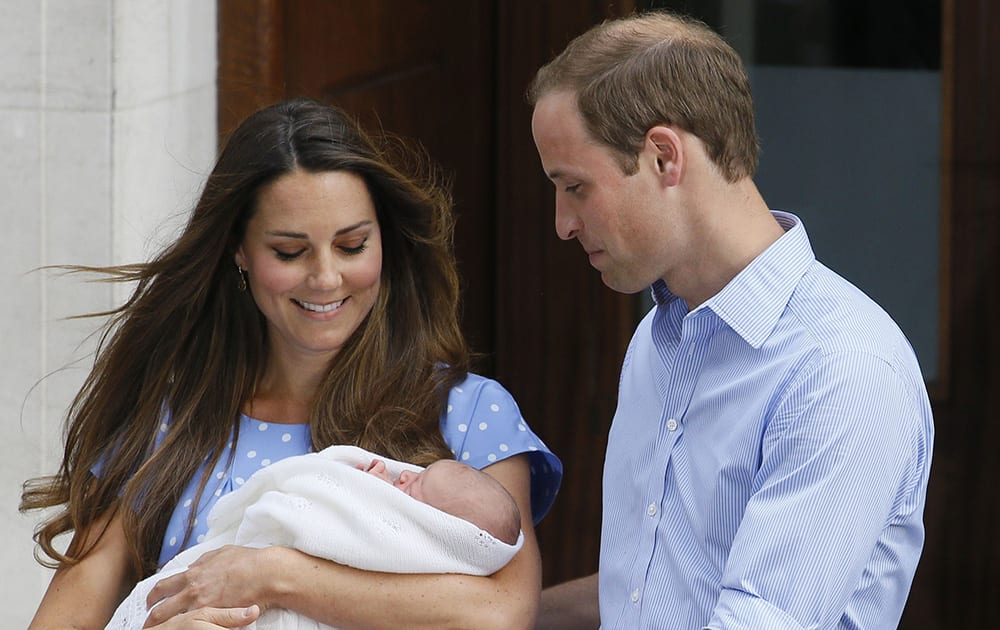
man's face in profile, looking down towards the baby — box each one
[531,91,669,293]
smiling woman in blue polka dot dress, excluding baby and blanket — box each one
[22,100,561,629]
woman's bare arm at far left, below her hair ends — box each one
[29,511,136,630]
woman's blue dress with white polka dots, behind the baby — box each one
[159,374,562,566]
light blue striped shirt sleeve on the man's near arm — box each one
[706,353,932,630]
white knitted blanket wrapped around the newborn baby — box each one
[106,446,524,630]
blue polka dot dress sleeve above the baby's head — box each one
[441,374,562,524]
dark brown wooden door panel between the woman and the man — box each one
[496,0,636,584]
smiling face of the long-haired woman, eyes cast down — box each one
[236,170,382,360]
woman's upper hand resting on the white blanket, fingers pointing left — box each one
[145,545,268,628]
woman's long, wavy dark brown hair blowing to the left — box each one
[21,99,469,576]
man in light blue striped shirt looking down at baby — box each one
[529,13,933,630]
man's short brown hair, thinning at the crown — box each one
[527,11,759,182]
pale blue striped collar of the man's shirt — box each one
[651,210,816,348]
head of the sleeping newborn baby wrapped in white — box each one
[395,459,521,545]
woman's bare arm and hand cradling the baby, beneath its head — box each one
[147,455,541,630]
